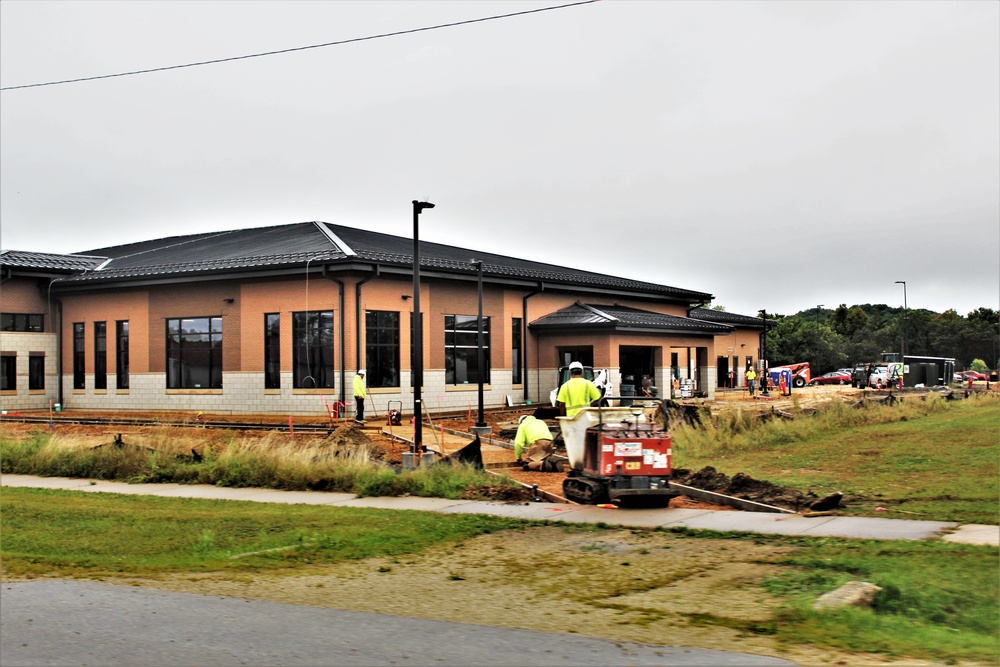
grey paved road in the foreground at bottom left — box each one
[0,581,795,667]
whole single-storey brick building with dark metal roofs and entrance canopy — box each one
[0,222,761,415]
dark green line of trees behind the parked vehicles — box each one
[767,304,1000,377]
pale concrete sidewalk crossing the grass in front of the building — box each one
[0,475,1000,546]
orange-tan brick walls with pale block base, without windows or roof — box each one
[3,272,728,416]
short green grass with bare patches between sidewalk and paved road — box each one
[0,488,1000,664]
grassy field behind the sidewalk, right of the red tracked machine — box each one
[673,394,1000,524]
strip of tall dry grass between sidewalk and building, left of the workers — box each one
[0,430,527,499]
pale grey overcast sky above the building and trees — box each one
[0,0,1000,315]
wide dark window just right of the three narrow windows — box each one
[167,316,222,389]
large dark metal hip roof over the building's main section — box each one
[3,222,712,304]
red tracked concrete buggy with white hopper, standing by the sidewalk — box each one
[558,395,680,505]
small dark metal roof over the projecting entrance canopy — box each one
[528,301,732,336]
